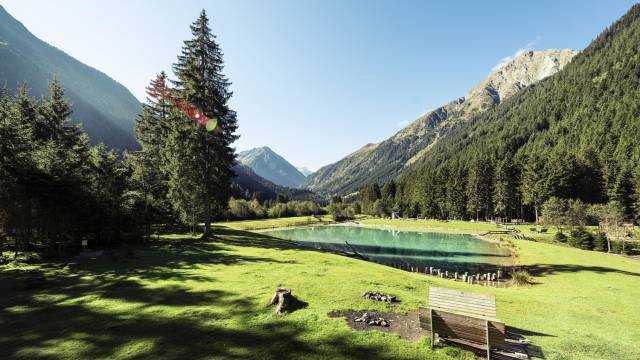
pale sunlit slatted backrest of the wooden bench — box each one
[429,287,496,319]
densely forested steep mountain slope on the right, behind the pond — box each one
[397,5,640,218]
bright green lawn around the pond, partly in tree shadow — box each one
[0,219,640,359]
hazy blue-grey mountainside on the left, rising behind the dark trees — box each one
[0,6,141,149]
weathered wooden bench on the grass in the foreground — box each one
[419,287,521,359]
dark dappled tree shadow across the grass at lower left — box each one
[0,231,416,359]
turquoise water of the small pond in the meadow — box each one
[264,226,511,271]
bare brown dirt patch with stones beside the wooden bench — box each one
[327,310,429,340]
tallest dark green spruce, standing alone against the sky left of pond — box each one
[173,10,238,237]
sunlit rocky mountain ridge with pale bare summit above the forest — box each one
[304,49,577,194]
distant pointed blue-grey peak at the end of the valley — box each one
[238,146,305,188]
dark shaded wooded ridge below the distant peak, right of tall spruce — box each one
[232,164,322,202]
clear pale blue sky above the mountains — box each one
[0,0,633,170]
